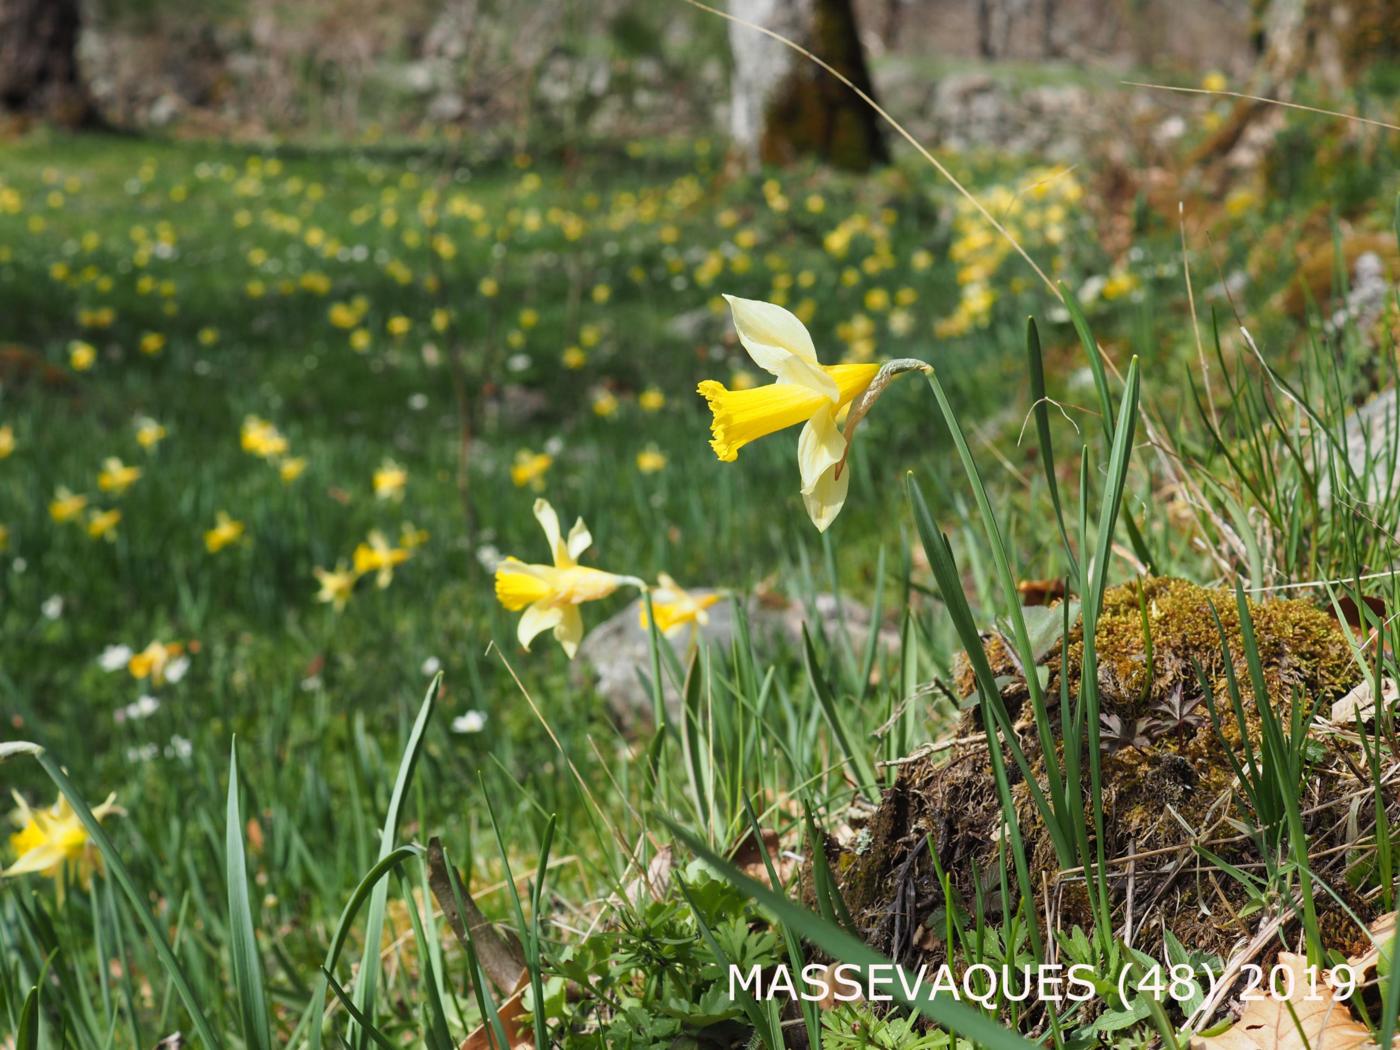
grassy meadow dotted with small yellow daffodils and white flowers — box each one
[0,84,1400,1050]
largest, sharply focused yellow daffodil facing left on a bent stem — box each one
[697,295,879,532]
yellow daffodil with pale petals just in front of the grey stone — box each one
[496,500,640,659]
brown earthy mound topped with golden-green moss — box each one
[837,578,1371,965]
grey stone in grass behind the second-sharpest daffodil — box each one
[574,589,899,728]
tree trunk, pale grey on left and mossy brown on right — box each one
[729,0,889,171]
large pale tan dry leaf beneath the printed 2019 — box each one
[1191,952,1376,1050]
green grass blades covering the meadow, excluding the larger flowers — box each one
[0,114,1396,1047]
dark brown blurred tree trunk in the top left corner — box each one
[0,0,97,127]
